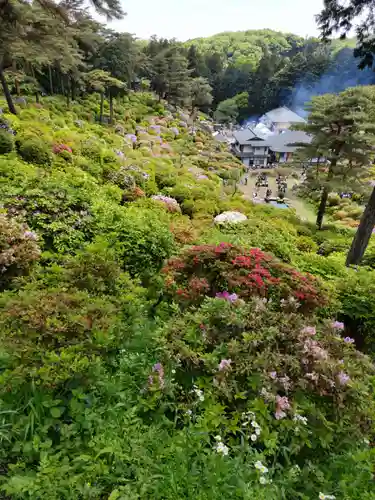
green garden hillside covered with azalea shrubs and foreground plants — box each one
[0,92,375,500]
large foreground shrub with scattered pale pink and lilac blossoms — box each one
[159,297,375,498]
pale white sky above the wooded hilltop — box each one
[106,0,323,41]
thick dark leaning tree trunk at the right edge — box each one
[346,188,375,266]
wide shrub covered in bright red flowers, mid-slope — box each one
[164,243,326,312]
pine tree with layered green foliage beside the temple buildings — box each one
[298,87,375,229]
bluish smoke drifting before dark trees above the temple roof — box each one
[291,48,375,117]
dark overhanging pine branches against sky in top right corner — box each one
[317,0,375,69]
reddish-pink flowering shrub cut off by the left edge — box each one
[0,214,40,290]
